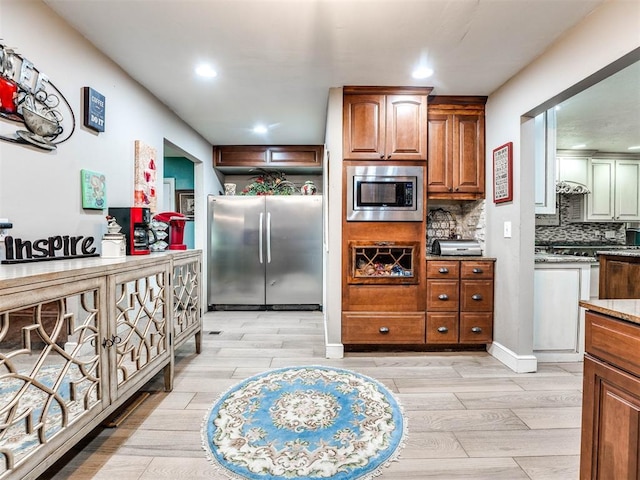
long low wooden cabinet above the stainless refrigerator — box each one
[213,145,324,171]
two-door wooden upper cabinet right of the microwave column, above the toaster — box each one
[427,97,486,200]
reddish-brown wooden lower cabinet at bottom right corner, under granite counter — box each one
[580,311,640,480]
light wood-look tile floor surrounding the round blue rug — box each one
[41,311,582,480]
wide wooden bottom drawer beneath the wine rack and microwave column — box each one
[342,312,425,344]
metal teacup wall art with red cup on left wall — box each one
[0,43,76,151]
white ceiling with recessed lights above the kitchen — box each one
[44,0,640,153]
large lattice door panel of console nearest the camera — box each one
[0,278,108,479]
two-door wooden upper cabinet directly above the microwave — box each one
[343,87,431,160]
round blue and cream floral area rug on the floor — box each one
[202,366,406,480]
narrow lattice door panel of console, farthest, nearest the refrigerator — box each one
[172,254,202,353]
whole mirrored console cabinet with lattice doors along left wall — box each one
[0,250,202,480]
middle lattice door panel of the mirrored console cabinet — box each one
[108,263,173,401]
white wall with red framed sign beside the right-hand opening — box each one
[486,0,640,372]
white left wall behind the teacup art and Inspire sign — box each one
[0,0,219,292]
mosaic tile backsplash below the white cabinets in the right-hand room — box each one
[536,195,626,245]
